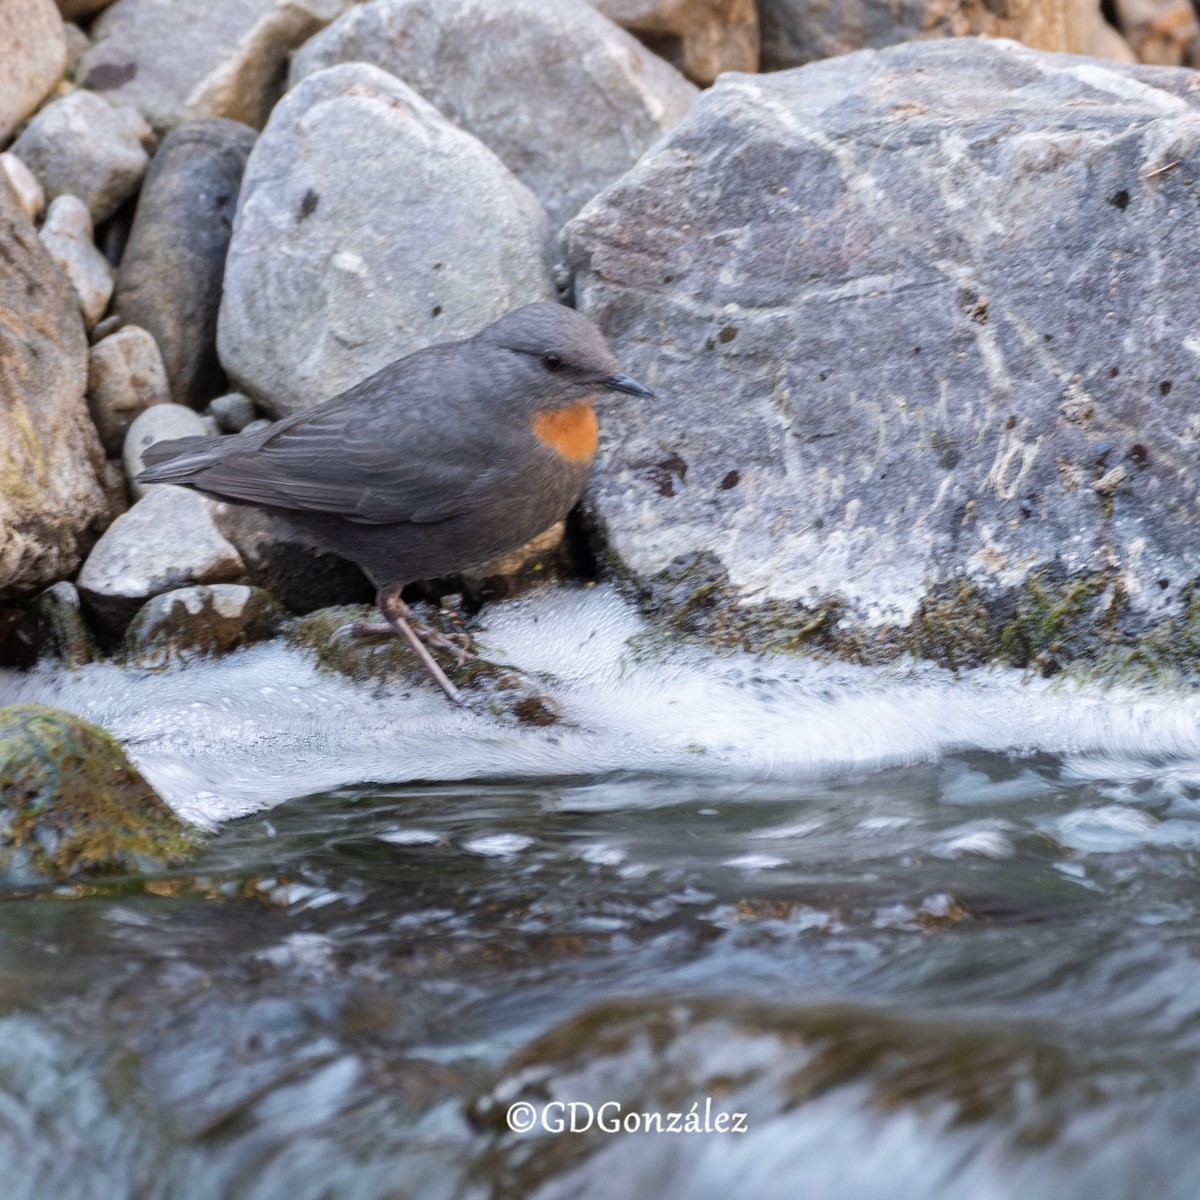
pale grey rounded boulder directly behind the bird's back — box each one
[217,64,554,416]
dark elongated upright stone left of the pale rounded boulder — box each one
[113,116,254,408]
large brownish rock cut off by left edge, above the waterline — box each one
[0,175,109,600]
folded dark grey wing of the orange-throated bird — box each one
[140,372,498,524]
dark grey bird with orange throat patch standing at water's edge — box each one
[137,301,654,703]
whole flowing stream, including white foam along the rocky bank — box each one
[0,588,1200,1200]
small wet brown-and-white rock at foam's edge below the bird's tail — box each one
[121,583,282,667]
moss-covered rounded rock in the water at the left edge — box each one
[0,704,200,886]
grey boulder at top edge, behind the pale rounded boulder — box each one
[290,0,696,228]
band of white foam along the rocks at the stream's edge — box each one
[0,588,1200,823]
